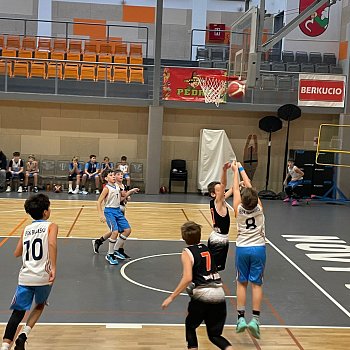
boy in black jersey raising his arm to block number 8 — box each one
[208,162,232,271]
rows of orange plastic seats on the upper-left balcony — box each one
[0,35,144,84]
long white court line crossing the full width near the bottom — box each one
[0,322,350,330]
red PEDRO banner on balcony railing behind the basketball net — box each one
[163,67,226,102]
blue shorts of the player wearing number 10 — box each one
[10,285,52,310]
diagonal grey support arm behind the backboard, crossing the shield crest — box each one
[262,0,338,52]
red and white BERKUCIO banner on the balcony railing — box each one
[298,74,345,107]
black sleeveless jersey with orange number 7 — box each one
[186,243,221,287]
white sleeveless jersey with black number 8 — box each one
[236,204,265,247]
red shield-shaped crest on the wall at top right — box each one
[299,0,330,37]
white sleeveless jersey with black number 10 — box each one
[18,220,51,286]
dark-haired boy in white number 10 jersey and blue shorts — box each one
[1,194,58,350]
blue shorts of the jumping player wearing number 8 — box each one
[236,246,266,285]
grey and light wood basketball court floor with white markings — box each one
[0,195,350,350]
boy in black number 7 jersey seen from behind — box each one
[162,221,233,350]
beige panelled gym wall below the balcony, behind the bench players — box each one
[0,101,338,192]
